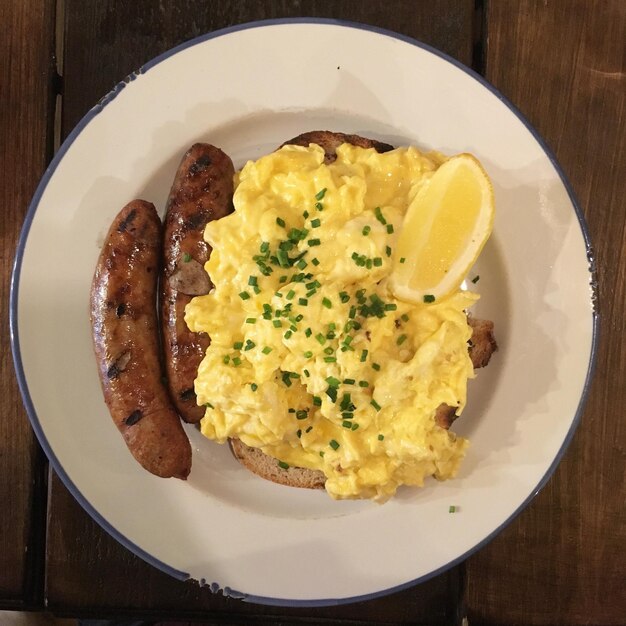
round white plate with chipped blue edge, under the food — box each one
[11,20,597,605]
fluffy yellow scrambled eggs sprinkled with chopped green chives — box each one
[186,144,478,501]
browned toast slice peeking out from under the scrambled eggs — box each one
[229,130,497,489]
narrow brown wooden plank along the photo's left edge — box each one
[0,0,54,608]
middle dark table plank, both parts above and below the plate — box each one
[46,0,474,624]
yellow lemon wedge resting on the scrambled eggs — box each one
[390,154,495,303]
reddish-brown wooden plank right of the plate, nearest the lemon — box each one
[467,0,626,625]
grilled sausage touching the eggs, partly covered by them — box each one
[161,143,235,423]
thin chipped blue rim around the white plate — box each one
[9,17,600,607]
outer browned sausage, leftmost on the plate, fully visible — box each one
[91,200,191,479]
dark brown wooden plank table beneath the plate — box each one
[0,0,626,626]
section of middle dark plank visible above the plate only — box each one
[63,0,474,132]
